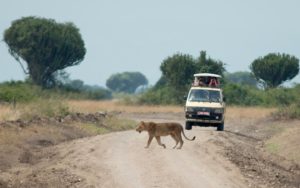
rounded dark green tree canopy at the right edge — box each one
[250,53,299,88]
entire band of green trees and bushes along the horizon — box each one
[0,17,300,118]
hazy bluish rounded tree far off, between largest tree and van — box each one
[106,72,148,93]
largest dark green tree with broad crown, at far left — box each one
[4,17,86,87]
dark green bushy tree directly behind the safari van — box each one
[151,51,225,104]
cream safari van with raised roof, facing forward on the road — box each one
[185,73,225,131]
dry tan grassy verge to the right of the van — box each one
[225,107,300,164]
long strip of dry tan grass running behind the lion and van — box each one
[0,100,276,121]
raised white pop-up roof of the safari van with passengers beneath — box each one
[192,73,222,88]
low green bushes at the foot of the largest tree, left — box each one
[0,81,112,103]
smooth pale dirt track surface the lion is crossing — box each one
[32,119,246,188]
